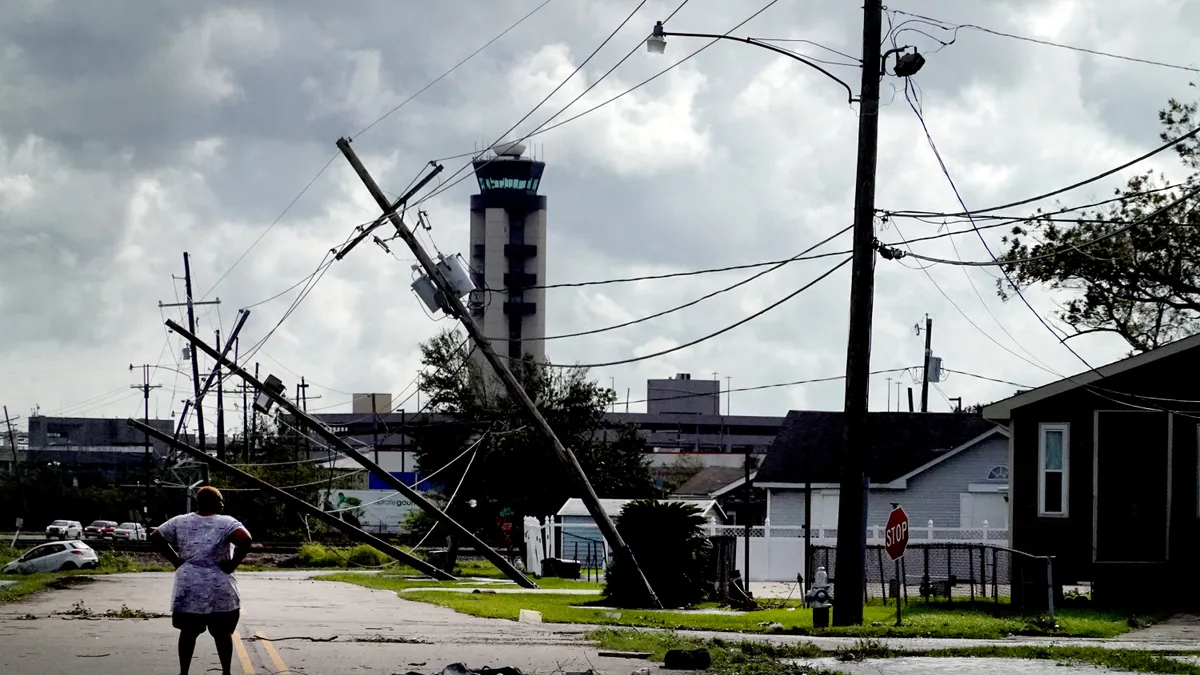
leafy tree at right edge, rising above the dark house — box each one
[997,90,1200,352]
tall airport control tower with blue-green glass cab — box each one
[469,138,546,363]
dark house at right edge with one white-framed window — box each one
[983,335,1200,607]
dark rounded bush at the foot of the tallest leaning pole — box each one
[604,500,710,608]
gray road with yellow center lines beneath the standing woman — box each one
[0,572,628,675]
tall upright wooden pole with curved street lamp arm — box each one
[646,5,925,626]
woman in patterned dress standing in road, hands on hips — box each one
[150,486,251,675]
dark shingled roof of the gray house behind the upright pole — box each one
[756,411,1003,484]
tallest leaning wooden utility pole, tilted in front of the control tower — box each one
[337,136,662,605]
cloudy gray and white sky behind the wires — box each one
[0,0,1200,429]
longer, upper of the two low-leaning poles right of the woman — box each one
[167,318,538,589]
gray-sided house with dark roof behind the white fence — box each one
[755,411,1008,543]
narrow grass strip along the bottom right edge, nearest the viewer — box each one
[588,629,1200,675]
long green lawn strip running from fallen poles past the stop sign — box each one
[320,573,1130,639]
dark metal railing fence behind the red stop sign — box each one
[811,543,1055,613]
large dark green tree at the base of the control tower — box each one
[412,331,658,545]
